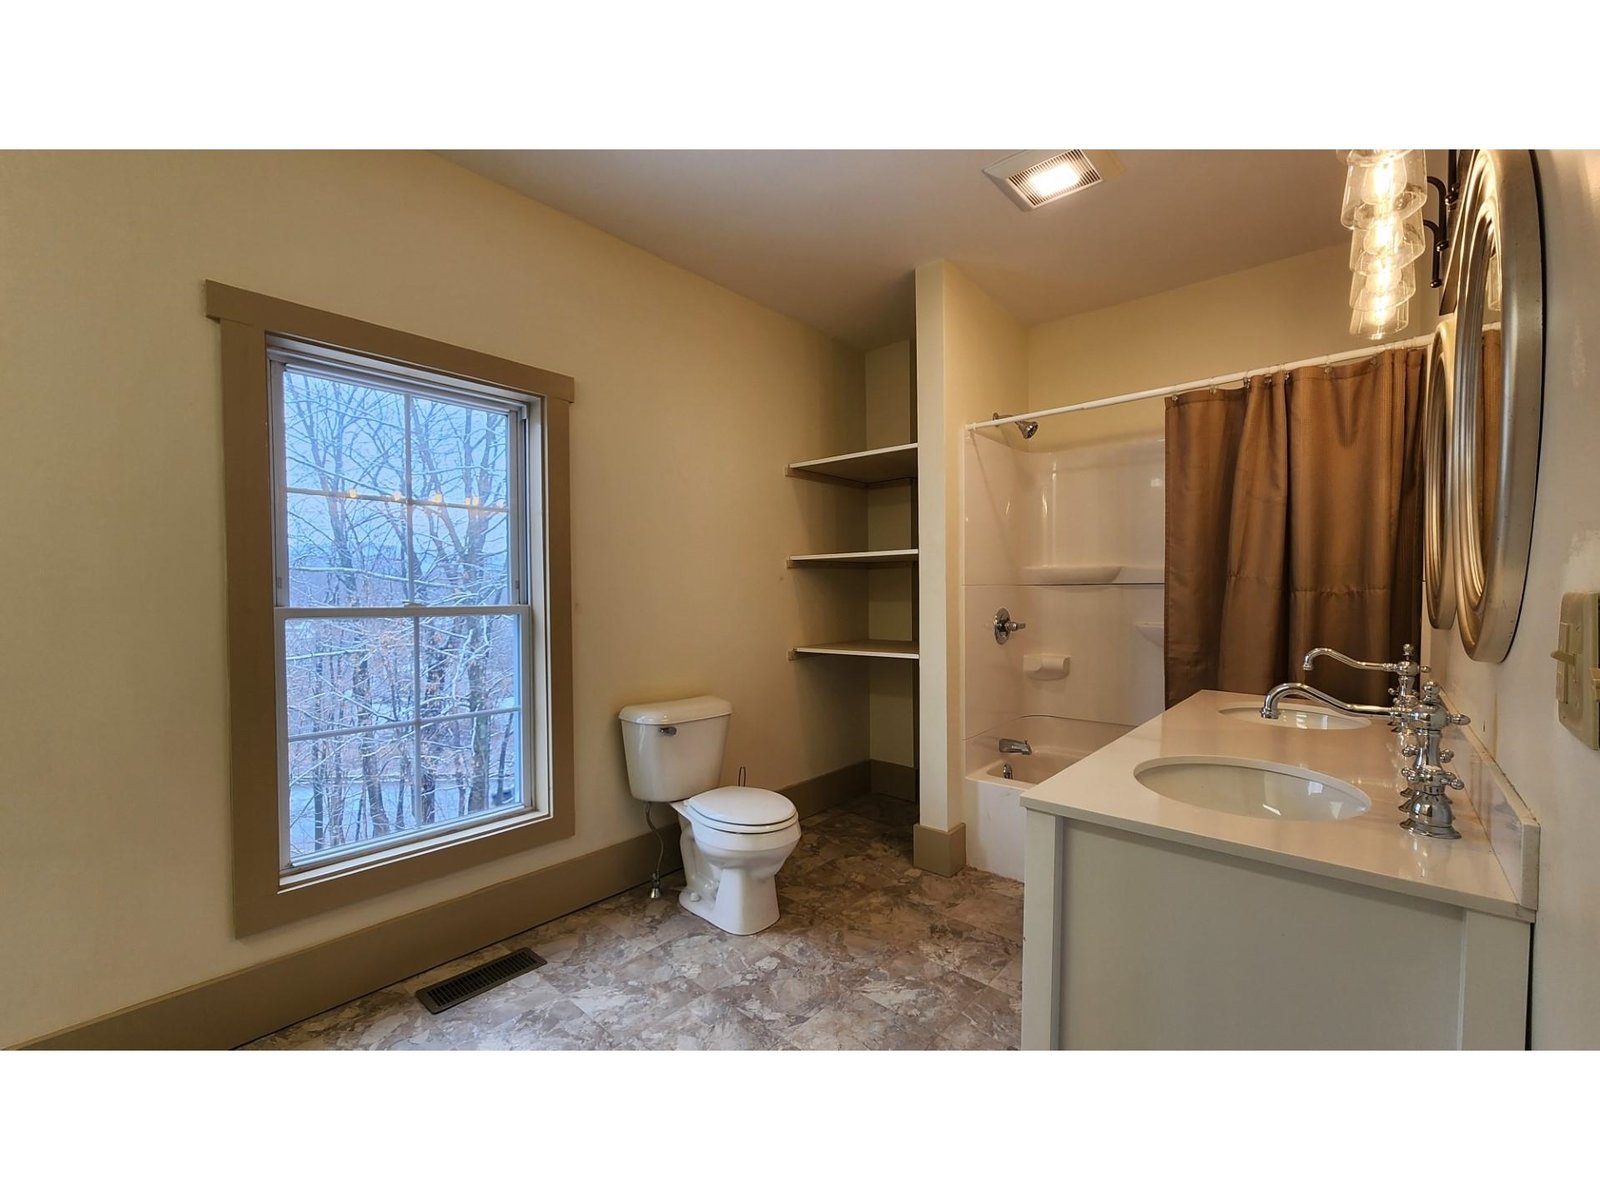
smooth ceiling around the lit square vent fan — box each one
[443,150,1346,349]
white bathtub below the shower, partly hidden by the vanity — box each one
[963,717,1133,880]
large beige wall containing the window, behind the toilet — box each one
[0,154,867,1045]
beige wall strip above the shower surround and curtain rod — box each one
[1024,240,1437,450]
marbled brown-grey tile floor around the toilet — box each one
[246,797,1022,1050]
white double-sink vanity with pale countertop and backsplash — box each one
[1022,691,1538,1048]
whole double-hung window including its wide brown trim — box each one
[208,285,574,933]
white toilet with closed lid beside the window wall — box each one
[618,696,800,934]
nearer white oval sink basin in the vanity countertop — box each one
[1133,755,1373,821]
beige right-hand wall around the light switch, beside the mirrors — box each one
[1422,150,1600,1048]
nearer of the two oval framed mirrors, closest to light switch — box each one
[1448,150,1544,662]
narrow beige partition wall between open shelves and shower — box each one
[917,262,1027,829]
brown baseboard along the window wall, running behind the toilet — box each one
[16,760,870,1050]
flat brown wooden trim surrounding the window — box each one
[205,280,576,936]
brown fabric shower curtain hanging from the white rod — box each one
[1166,349,1427,707]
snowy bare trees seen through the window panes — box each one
[275,360,530,866]
